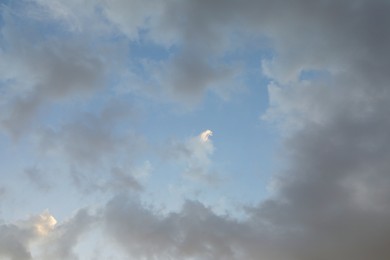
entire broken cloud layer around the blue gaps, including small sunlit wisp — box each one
[0,0,390,260]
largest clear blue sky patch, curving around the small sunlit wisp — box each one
[142,73,278,211]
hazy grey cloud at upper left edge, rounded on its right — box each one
[0,28,104,137]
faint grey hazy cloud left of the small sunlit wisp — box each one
[37,99,144,166]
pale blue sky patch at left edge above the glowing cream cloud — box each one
[0,138,65,220]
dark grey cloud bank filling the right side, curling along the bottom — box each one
[0,0,390,260]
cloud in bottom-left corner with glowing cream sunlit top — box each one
[0,209,96,260]
